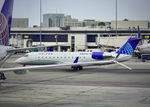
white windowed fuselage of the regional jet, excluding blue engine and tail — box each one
[16,52,131,65]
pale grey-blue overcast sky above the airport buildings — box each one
[13,0,150,26]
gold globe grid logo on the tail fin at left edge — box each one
[0,13,9,46]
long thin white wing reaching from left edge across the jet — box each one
[0,60,115,71]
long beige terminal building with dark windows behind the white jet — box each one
[10,18,150,51]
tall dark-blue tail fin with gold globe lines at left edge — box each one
[0,0,14,46]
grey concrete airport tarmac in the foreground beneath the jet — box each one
[0,56,150,107]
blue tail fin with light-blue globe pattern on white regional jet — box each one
[116,38,141,57]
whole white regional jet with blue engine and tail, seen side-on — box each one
[16,38,141,70]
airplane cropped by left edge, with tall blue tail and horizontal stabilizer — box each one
[0,0,61,80]
